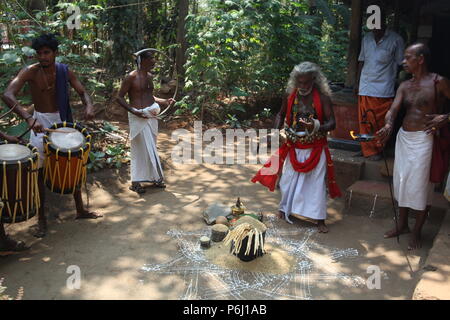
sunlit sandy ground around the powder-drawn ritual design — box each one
[0,129,441,299]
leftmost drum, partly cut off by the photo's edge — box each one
[0,141,40,223]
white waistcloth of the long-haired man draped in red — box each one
[279,149,327,223]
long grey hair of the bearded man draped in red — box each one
[286,61,331,97]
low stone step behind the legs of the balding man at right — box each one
[345,180,449,218]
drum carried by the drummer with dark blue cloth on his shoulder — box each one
[44,122,91,194]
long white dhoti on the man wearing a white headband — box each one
[128,103,164,182]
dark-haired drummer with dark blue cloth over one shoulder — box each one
[2,34,101,237]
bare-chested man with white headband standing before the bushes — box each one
[117,49,174,194]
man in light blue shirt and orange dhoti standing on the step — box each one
[355,3,404,161]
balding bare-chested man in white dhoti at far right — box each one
[377,43,450,250]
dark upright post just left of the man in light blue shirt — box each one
[345,0,362,87]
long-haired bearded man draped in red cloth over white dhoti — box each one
[252,62,341,233]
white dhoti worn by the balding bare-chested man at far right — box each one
[393,128,434,210]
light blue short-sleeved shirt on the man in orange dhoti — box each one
[358,30,405,98]
